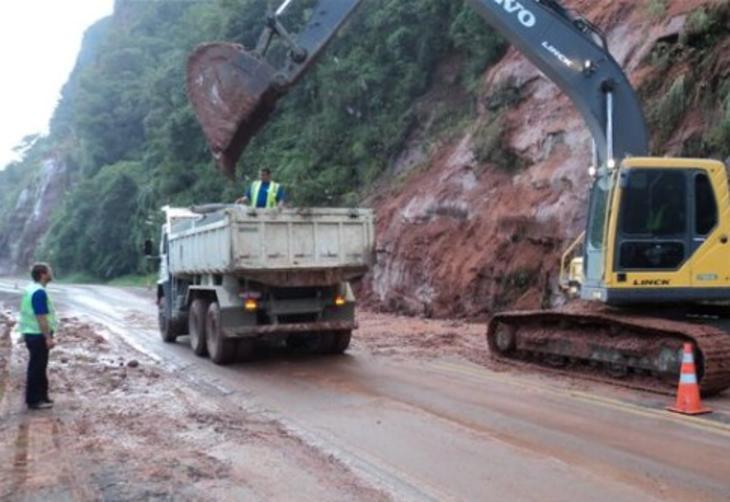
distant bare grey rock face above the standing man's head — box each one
[0,158,69,275]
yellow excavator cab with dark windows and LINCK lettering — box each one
[562,157,730,305]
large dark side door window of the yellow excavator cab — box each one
[618,169,690,270]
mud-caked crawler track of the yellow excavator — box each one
[487,307,730,396]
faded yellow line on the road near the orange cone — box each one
[431,362,730,438]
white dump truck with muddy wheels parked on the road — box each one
[145,205,374,364]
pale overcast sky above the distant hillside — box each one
[0,0,114,169]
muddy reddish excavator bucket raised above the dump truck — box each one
[186,43,283,178]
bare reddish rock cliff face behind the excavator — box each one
[364,0,728,317]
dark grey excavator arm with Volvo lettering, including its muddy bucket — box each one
[187,0,649,176]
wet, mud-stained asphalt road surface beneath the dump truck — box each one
[0,280,730,501]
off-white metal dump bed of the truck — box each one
[169,206,374,285]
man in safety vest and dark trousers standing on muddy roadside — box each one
[18,263,56,409]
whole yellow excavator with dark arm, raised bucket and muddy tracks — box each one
[187,0,730,395]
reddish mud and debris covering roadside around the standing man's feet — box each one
[0,310,386,500]
